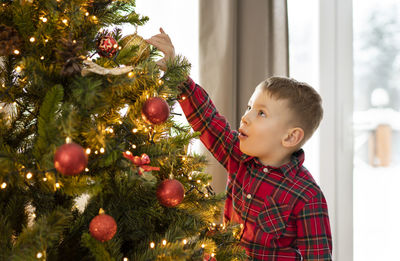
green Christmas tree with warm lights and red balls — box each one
[0,0,244,260]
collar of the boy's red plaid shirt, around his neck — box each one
[242,149,304,179]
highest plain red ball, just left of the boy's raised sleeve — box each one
[142,97,169,125]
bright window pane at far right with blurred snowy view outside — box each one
[353,0,400,261]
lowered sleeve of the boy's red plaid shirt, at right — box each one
[296,190,332,261]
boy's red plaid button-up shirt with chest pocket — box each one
[179,78,332,261]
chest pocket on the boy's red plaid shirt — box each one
[257,196,290,238]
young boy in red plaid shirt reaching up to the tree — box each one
[147,29,332,261]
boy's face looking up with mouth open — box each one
[239,87,292,162]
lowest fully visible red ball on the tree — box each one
[89,210,117,242]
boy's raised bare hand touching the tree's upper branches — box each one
[145,28,175,71]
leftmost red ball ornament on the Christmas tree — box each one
[54,143,88,176]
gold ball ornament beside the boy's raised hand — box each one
[119,34,150,64]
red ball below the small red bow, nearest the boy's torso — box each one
[157,179,185,207]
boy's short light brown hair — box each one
[258,76,323,145]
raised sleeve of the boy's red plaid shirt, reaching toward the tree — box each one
[179,78,242,173]
